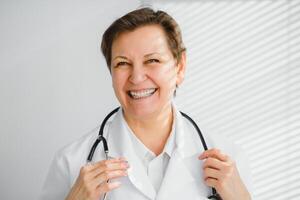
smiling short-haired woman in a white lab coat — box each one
[40,8,251,200]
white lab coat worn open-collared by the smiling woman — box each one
[40,105,251,200]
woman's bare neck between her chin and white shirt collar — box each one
[124,105,173,155]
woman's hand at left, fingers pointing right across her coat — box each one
[66,158,129,200]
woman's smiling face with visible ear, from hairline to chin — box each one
[111,25,185,119]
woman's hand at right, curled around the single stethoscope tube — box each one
[199,149,251,200]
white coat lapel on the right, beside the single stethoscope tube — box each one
[156,108,209,200]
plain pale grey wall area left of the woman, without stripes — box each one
[0,0,139,200]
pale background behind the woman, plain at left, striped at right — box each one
[0,0,300,200]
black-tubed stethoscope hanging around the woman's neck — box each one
[87,107,222,200]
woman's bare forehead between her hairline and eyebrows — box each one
[112,25,171,57]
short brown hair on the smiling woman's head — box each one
[101,8,186,70]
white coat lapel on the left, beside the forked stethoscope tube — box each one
[107,109,156,200]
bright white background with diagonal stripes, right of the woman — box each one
[142,0,300,200]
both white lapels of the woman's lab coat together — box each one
[107,105,209,200]
